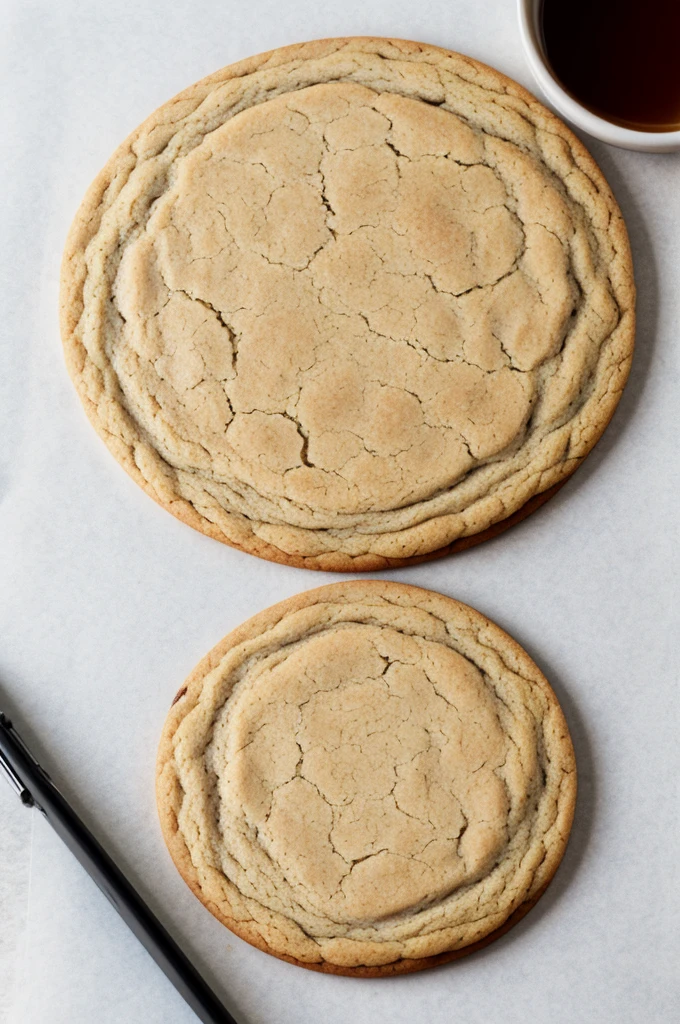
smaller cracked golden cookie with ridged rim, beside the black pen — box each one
[157,581,577,977]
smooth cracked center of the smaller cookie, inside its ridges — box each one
[207,627,516,924]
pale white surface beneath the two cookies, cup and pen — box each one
[0,0,680,1024]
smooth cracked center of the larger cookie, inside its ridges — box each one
[112,78,575,514]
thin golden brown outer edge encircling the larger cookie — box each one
[59,36,635,572]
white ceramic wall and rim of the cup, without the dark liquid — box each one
[517,0,680,153]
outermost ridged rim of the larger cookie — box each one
[59,36,635,572]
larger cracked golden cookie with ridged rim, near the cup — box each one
[61,39,634,570]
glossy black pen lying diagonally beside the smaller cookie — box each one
[0,713,237,1024]
